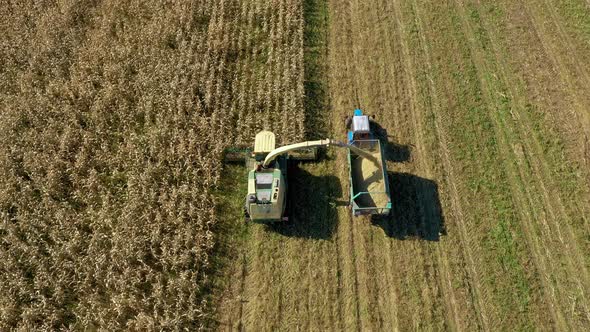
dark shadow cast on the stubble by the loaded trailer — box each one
[371,172,446,241]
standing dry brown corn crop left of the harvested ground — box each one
[0,0,305,330]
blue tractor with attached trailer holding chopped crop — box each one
[346,109,391,216]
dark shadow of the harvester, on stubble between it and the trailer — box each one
[268,165,348,240]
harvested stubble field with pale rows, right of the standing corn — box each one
[219,0,590,331]
